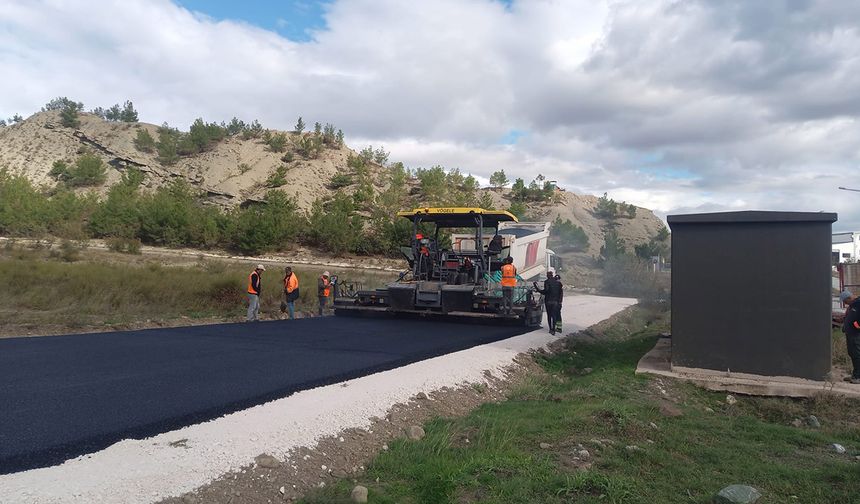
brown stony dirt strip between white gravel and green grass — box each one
[161,306,648,504]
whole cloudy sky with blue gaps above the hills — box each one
[0,0,860,230]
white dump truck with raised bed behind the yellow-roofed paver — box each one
[451,222,561,282]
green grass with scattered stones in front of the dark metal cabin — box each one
[303,311,860,504]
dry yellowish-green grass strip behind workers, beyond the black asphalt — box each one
[0,241,390,335]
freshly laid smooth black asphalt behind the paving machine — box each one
[0,317,525,474]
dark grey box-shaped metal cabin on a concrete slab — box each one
[668,212,836,380]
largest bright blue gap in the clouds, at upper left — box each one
[175,0,330,42]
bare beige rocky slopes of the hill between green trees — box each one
[0,111,664,286]
